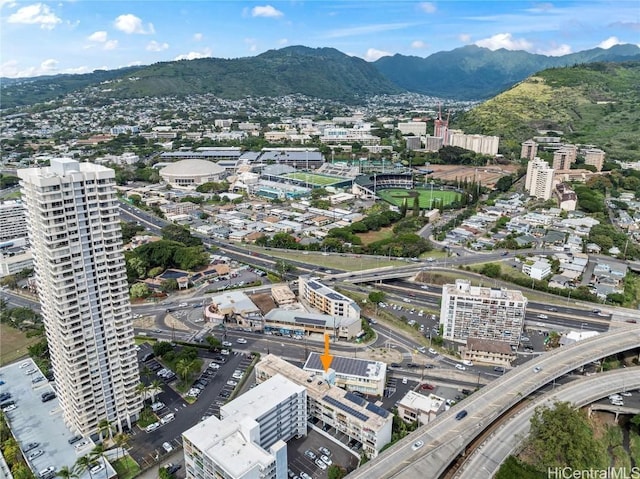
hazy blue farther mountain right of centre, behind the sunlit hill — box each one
[374,45,640,100]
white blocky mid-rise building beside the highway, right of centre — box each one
[440,279,527,344]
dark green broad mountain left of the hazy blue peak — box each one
[3,47,403,107]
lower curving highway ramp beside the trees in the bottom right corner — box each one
[454,367,640,479]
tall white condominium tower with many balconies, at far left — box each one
[18,158,142,434]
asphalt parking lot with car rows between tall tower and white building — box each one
[129,343,251,466]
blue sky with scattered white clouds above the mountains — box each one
[0,0,640,78]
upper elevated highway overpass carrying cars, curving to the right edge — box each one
[348,325,640,479]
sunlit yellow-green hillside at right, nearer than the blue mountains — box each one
[456,62,640,161]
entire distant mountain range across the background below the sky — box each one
[0,45,640,108]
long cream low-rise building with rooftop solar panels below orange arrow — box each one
[255,354,393,457]
